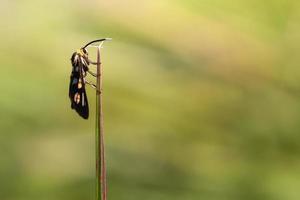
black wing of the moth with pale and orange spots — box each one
[69,53,89,119]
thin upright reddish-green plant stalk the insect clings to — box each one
[96,42,107,200]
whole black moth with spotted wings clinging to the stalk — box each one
[69,39,106,119]
